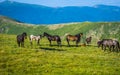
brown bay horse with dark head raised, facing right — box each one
[66,33,83,46]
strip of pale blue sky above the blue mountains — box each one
[0,0,120,7]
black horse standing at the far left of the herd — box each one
[16,32,27,47]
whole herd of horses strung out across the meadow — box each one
[16,32,120,52]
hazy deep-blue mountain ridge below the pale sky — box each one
[0,1,120,24]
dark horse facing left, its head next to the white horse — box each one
[43,32,61,46]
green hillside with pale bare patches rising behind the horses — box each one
[0,17,120,42]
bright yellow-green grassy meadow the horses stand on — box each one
[0,34,120,75]
